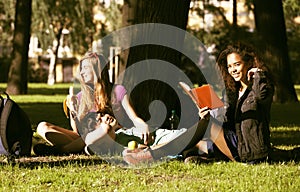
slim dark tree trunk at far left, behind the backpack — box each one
[6,0,31,95]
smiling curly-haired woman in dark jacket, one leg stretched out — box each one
[124,43,274,164]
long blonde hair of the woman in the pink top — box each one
[77,51,110,119]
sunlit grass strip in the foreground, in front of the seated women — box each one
[0,161,300,192]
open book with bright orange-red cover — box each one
[179,82,224,109]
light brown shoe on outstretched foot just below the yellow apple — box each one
[123,148,154,165]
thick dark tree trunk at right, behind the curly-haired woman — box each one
[254,0,298,103]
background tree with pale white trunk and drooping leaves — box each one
[32,0,97,85]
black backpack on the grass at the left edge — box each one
[0,92,33,157]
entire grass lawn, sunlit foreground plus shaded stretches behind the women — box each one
[0,84,300,192]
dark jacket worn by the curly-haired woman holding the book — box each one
[213,71,274,162]
